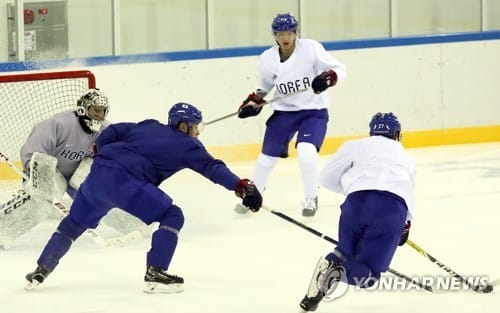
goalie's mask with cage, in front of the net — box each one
[76,89,109,133]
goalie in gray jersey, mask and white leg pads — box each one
[0,89,147,249]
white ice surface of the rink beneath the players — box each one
[0,143,500,313]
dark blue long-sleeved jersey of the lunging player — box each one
[96,119,239,190]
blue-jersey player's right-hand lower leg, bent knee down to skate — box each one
[144,205,184,293]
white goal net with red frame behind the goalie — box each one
[0,71,95,206]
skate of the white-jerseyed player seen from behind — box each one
[300,258,345,312]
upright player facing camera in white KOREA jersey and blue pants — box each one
[235,13,346,217]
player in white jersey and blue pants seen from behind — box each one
[300,113,416,311]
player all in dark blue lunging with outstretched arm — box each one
[26,103,262,293]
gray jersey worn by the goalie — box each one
[21,111,109,178]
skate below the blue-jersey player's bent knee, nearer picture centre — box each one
[144,266,184,293]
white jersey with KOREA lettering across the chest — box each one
[259,38,346,111]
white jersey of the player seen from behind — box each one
[320,136,416,220]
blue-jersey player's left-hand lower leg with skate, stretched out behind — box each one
[25,216,86,290]
